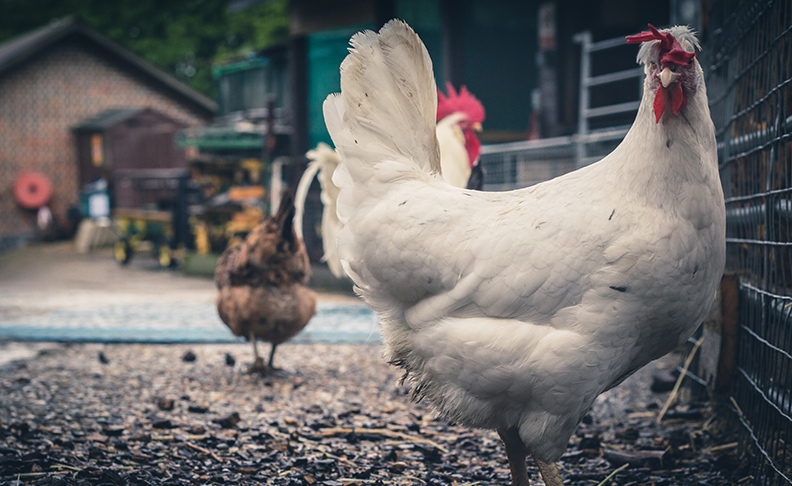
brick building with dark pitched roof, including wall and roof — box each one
[0,18,217,252]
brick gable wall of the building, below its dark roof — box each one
[0,38,206,251]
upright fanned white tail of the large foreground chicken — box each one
[324,20,440,195]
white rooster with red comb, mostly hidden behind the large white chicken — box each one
[294,83,485,278]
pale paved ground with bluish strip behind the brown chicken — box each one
[0,242,379,359]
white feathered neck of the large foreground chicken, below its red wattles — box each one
[603,68,720,203]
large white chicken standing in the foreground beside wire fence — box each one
[324,20,725,486]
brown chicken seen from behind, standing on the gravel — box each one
[215,192,316,372]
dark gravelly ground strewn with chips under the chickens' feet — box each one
[0,343,743,486]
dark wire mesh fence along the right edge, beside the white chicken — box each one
[702,0,792,486]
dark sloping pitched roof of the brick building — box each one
[0,17,217,116]
